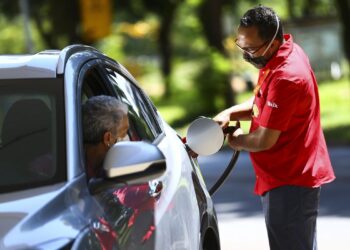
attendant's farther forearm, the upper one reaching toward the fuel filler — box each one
[213,97,254,127]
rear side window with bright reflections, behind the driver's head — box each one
[106,68,162,141]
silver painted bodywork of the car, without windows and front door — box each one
[0,46,220,250]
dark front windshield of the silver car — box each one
[0,79,66,193]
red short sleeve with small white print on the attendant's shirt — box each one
[260,79,301,131]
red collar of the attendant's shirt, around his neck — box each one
[261,34,293,71]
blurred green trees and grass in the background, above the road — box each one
[0,0,350,145]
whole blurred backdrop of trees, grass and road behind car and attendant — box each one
[0,0,350,250]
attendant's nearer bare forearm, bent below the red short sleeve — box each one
[228,127,281,152]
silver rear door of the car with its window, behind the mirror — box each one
[98,60,200,249]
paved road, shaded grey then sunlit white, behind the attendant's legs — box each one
[198,148,350,250]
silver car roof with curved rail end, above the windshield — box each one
[0,45,100,79]
